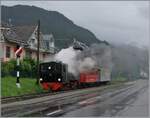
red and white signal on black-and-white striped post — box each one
[15,45,23,88]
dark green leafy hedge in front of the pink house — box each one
[1,58,37,78]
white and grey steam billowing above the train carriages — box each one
[44,44,112,76]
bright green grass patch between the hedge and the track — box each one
[1,77,44,97]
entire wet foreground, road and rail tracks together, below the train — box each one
[2,80,149,117]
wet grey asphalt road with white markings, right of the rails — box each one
[39,80,149,117]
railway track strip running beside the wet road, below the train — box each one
[2,84,135,116]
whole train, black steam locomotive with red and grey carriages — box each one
[40,61,110,91]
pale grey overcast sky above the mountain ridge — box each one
[2,1,150,46]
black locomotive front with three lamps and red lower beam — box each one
[40,62,68,91]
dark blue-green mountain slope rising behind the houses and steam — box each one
[1,5,105,48]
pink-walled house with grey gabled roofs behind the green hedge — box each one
[0,25,55,61]
